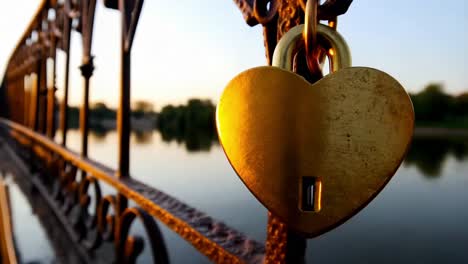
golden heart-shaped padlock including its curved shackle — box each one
[216,25,414,237]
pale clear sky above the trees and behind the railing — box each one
[0,0,468,109]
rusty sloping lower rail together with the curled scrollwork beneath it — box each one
[0,118,264,263]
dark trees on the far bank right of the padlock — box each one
[410,84,468,127]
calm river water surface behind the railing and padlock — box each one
[6,131,468,263]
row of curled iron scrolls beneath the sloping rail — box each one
[20,146,168,263]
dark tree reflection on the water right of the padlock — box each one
[404,138,468,178]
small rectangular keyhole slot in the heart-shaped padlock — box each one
[301,176,322,212]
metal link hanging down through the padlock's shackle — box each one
[303,0,322,74]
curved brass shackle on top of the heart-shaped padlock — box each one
[272,24,351,72]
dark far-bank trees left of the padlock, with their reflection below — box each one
[68,99,217,151]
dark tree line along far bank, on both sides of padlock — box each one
[69,84,468,132]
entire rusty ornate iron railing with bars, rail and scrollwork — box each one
[0,0,351,263]
